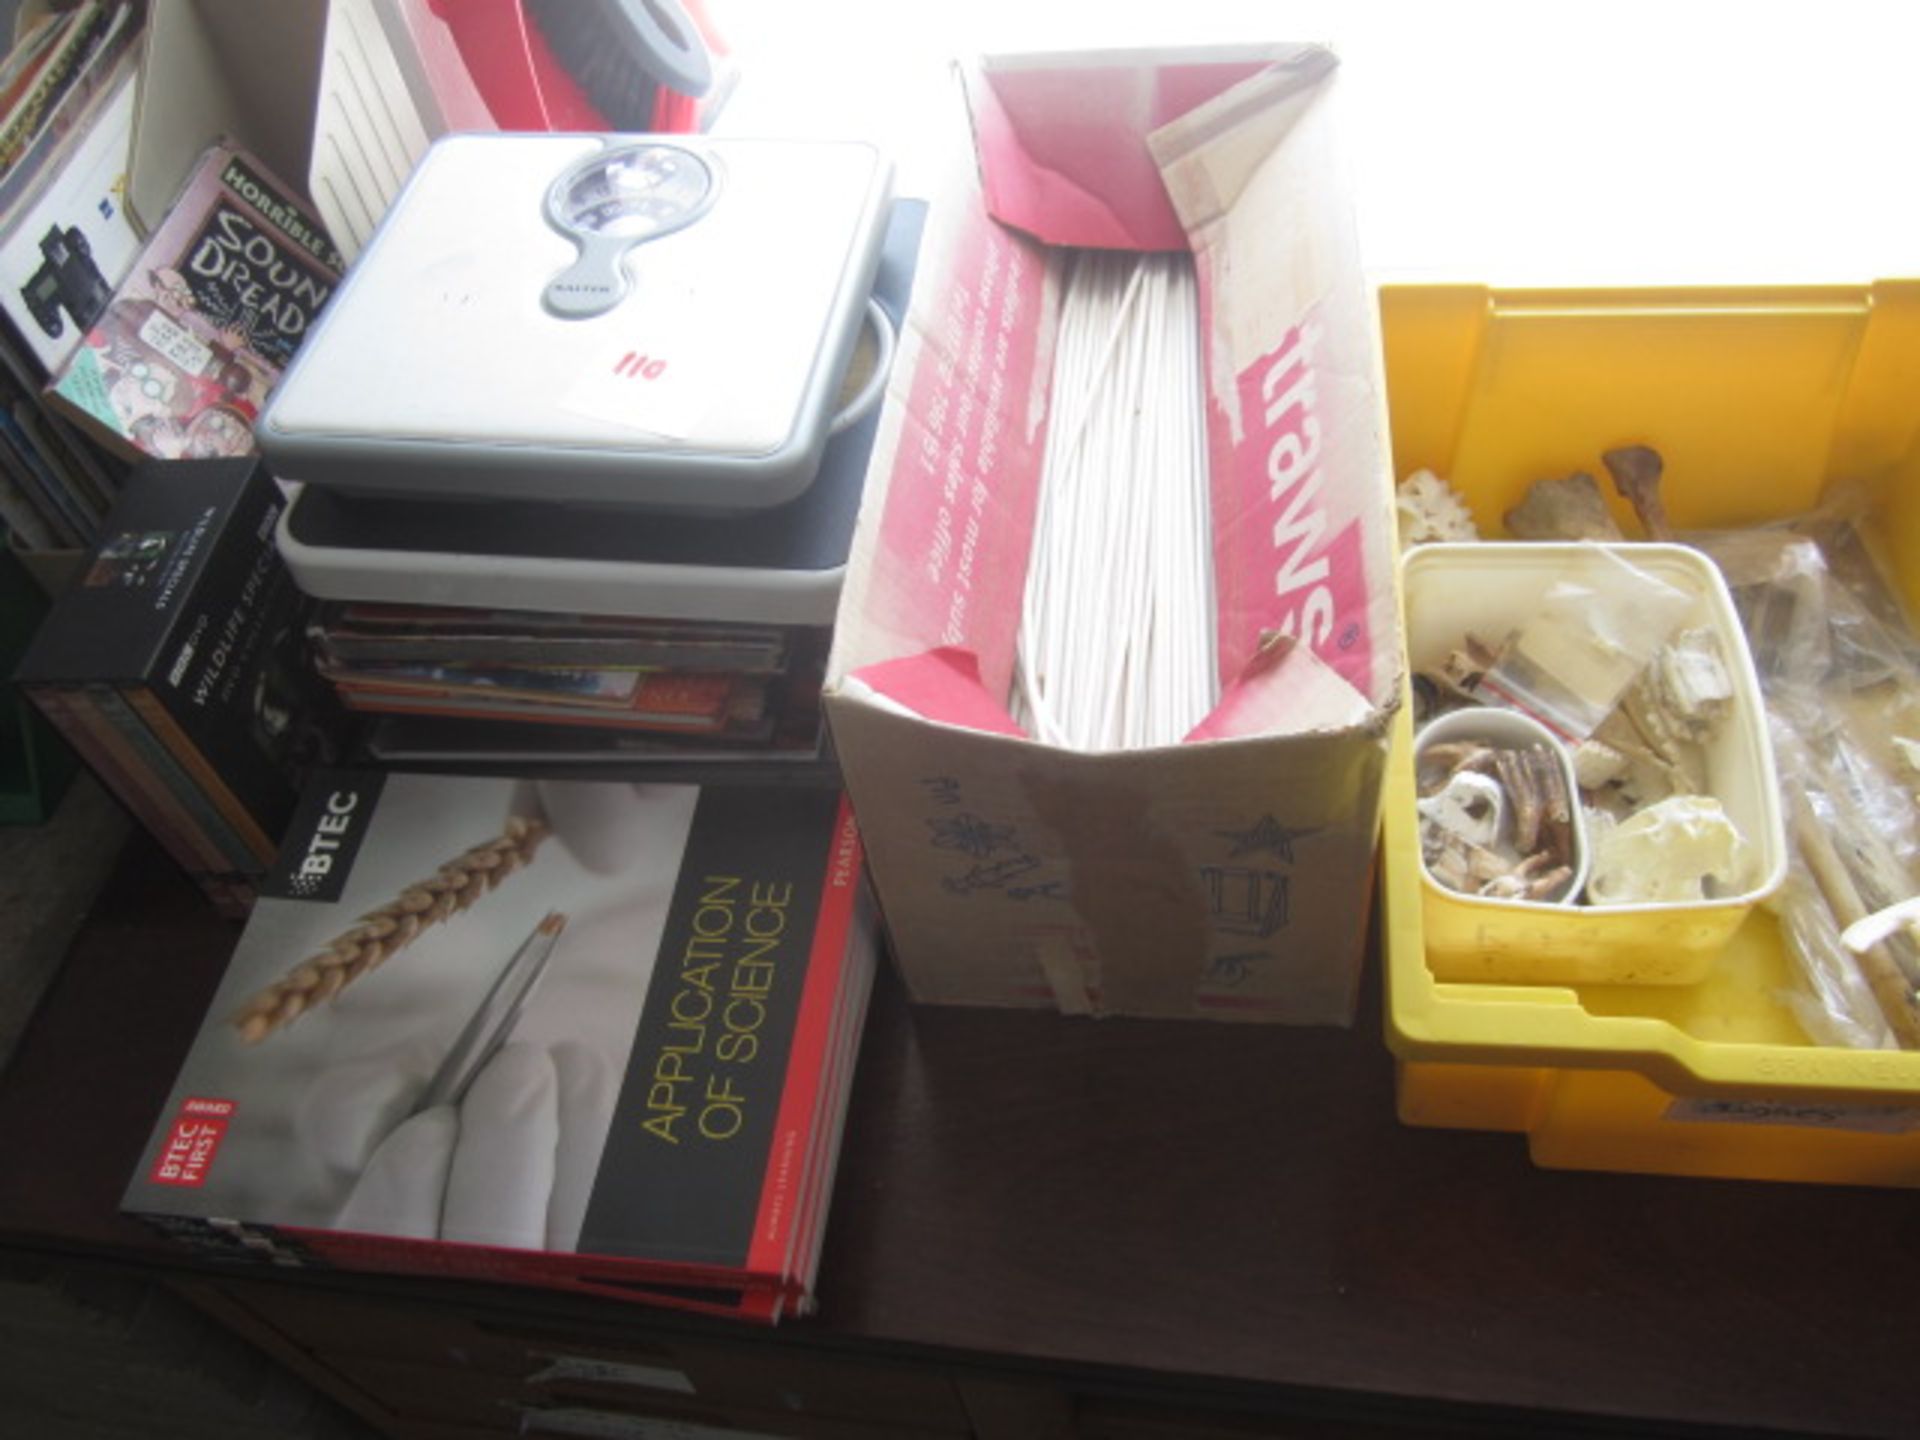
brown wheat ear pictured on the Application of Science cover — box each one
[232,816,551,1044]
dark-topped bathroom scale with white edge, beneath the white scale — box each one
[278,200,927,624]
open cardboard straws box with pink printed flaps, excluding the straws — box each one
[826,46,1404,1023]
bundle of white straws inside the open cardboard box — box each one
[1014,250,1217,751]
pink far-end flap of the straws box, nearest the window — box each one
[964,46,1325,250]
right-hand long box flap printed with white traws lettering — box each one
[1152,57,1402,708]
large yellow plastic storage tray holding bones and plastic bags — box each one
[1380,280,1920,1187]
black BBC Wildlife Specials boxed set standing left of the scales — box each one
[13,459,332,914]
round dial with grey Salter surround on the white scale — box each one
[541,140,720,319]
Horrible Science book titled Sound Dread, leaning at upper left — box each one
[46,142,342,461]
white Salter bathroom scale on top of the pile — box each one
[255,134,891,511]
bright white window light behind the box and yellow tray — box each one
[707,0,1920,284]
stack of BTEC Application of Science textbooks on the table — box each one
[123,770,876,1321]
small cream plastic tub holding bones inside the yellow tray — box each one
[1402,541,1788,985]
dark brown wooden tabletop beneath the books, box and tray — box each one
[0,837,1920,1436]
